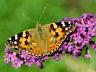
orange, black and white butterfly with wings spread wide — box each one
[5,21,75,56]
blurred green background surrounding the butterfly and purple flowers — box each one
[0,0,96,72]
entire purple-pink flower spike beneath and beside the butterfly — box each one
[4,14,96,68]
